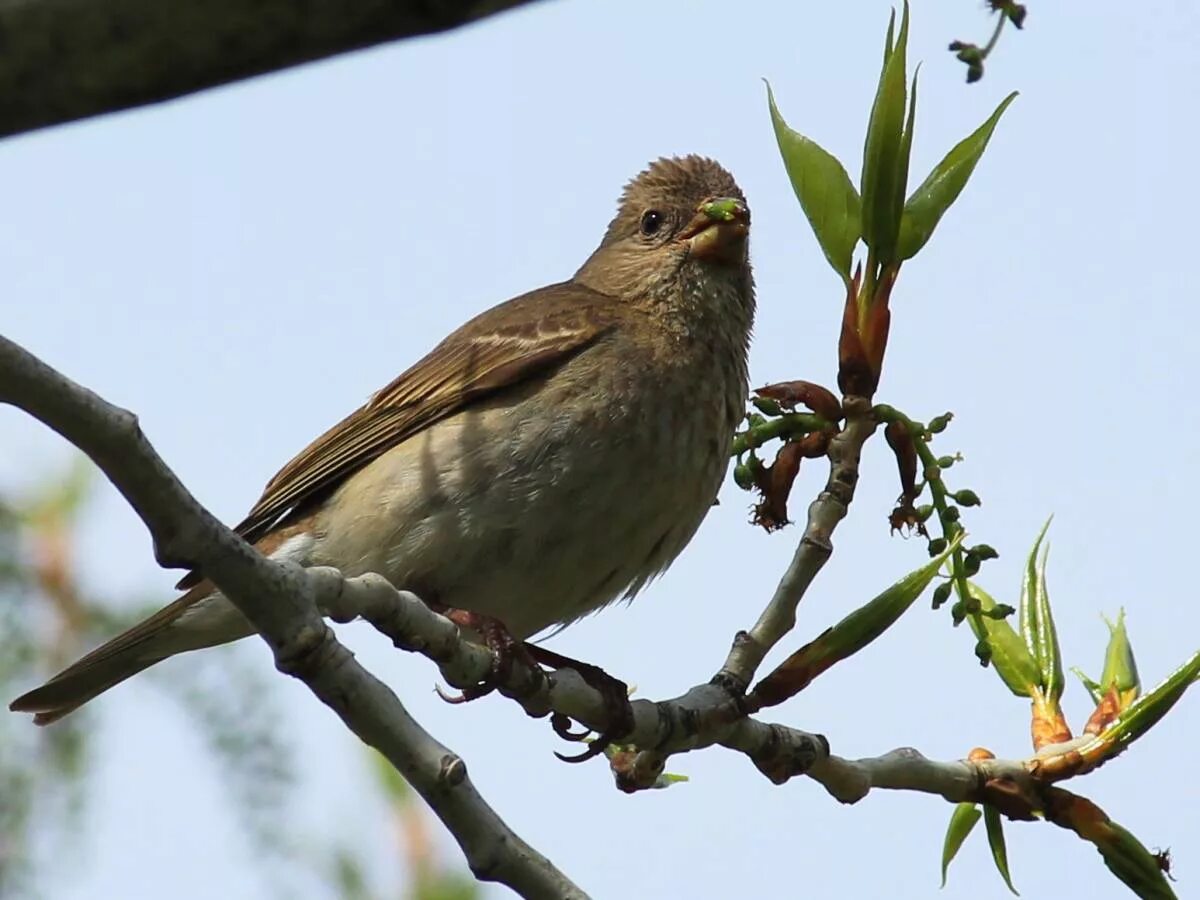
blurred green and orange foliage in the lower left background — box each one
[0,457,479,900]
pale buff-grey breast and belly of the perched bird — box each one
[318,324,745,637]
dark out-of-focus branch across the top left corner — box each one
[0,0,544,137]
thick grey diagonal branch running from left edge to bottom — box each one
[0,337,586,900]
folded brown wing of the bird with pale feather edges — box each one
[179,282,616,588]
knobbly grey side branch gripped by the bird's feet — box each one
[306,568,1093,818]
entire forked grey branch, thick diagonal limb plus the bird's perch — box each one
[0,328,1123,898]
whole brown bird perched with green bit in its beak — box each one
[11,156,754,725]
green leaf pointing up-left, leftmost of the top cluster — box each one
[767,83,863,283]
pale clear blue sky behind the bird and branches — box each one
[0,0,1200,900]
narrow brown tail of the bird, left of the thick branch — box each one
[8,582,253,725]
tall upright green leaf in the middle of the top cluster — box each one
[862,0,908,264]
